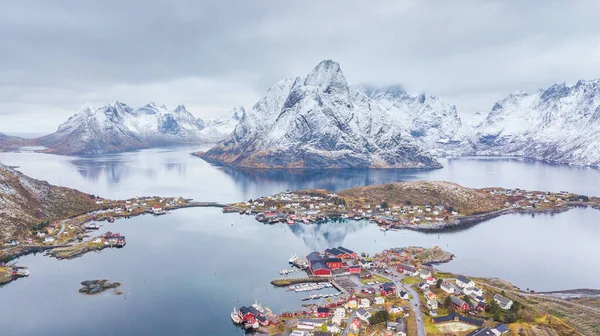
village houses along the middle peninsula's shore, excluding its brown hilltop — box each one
[223,188,600,230]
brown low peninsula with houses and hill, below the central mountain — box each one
[223,181,600,230]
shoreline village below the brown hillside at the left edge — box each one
[0,197,206,284]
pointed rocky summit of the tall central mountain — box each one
[304,60,348,94]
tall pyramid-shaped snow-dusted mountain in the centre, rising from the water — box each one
[199,60,441,168]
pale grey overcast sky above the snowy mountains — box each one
[0,0,600,132]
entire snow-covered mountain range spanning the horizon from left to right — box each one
[0,60,600,168]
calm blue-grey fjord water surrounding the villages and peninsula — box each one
[0,147,600,335]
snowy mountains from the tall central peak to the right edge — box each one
[197,61,600,168]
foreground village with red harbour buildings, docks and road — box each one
[231,246,560,336]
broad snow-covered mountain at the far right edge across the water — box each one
[471,79,600,166]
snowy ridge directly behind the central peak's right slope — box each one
[357,85,468,155]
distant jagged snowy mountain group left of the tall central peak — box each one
[38,101,231,155]
